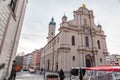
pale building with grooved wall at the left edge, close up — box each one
[0,0,28,80]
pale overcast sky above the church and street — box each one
[17,0,120,54]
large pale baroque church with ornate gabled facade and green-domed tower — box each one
[41,4,108,71]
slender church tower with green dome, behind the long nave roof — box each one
[47,17,56,42]
